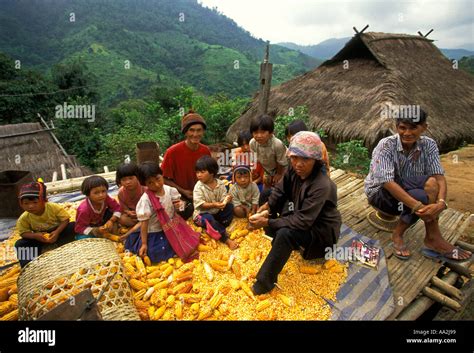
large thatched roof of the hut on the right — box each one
[227,32,474,150]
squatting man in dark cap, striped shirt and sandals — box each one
[365,109,472,260]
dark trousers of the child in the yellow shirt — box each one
[15,222,76,267]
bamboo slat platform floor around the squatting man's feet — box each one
[331,169,470,319]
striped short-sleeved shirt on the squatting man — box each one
[364,134,444,198]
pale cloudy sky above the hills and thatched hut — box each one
[198,0,474,50]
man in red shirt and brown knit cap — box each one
[161,110,211,219]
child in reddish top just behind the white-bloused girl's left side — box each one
[116,163,145,228]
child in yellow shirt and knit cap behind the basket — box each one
[15,182,74,267]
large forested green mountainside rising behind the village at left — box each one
[0,0,321,105]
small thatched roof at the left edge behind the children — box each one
[0,123,90,182]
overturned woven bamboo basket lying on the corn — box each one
[18,239,140,320]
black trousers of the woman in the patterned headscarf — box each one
[257,228,311,291]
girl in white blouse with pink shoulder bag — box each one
[125,162,199,262]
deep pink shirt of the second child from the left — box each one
[74,195,121,235]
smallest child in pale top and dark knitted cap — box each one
[231,165,260,218]
